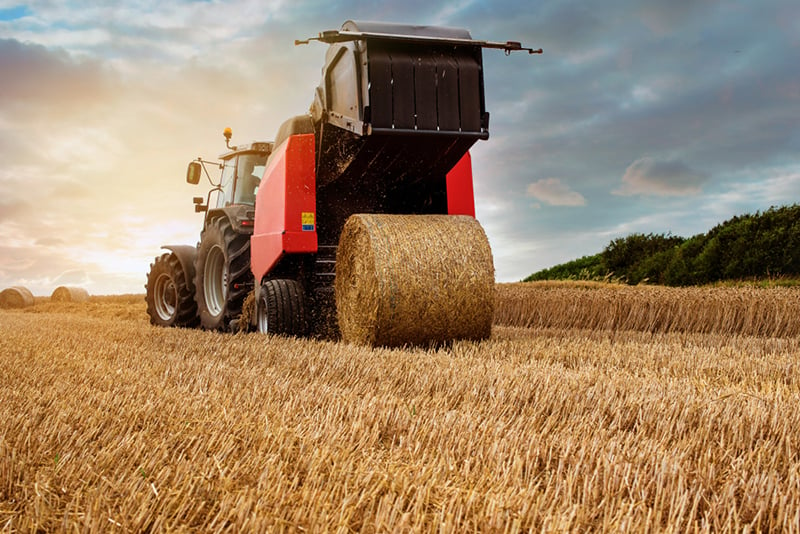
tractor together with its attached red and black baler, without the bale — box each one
[145,21,541,344]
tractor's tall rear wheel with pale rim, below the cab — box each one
[194,217,253,331]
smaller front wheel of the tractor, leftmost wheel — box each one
[144,253,198,327]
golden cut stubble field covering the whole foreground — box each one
[0,286,800,532]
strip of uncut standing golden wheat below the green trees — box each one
[494,282,800,336]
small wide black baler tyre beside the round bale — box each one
[256,279,308,336]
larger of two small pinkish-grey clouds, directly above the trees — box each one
[613,157,708,196]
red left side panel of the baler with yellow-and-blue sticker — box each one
[250,134,317,283]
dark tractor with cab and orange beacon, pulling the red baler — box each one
[146,135,273,330]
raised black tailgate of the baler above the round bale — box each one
[311,21,489,196]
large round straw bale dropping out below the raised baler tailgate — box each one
[334,214,494,346]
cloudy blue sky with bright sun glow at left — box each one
[0,0,800,295]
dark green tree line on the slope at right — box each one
[525,204,800,286]
